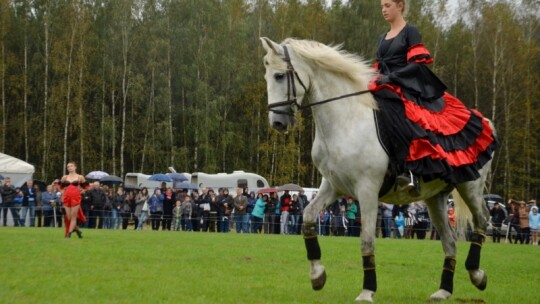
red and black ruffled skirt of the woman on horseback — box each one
[370,82,498,184]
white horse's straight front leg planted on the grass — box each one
[356,198,379,303]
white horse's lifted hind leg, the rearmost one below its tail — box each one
[457,179,489,290]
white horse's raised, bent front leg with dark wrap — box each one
[303,179,336,290]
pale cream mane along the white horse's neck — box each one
[282,38,376,108]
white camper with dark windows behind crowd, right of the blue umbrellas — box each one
[191,171,269,193]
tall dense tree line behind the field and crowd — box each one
[0,0,540,199]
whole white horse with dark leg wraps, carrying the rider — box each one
[261,38,491,302]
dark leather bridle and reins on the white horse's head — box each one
[268,45,370,116]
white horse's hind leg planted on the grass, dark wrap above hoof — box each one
[426,193,456,300]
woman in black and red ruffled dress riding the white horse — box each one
[369,0,498,196]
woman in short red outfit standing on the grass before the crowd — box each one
[58,161,88,238]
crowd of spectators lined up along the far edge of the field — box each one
[0,178,540,245]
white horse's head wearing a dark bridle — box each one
[261,37,307,131]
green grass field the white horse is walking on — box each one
[0,227,540,304]
